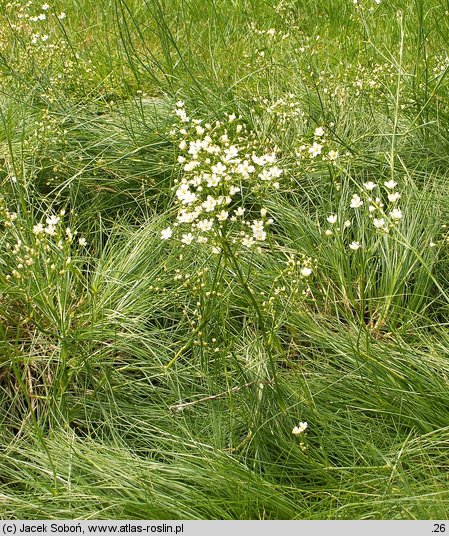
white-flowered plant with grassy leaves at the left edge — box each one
[0,197,88,335]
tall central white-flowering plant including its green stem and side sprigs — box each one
[160,101,313,370]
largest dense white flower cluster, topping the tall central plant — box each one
[161,101,283,252]
